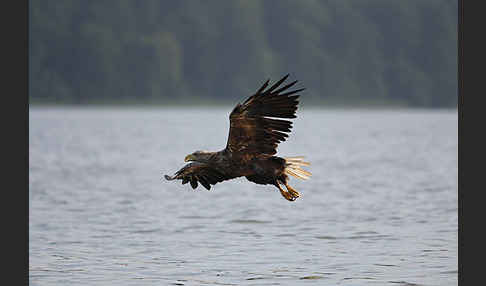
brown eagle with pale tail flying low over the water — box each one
[164,74,311,201]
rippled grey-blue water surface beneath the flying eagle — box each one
[29,108,458,285]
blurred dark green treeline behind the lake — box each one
[29,0,457,107]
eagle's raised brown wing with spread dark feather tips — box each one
[226,75,304,159]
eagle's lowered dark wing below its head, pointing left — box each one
[165,162,231,190]
